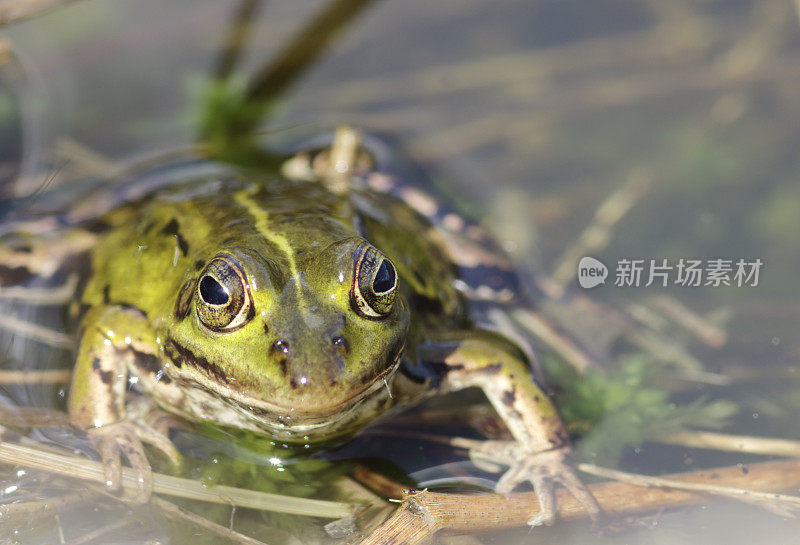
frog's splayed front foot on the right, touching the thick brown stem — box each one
[469,441,601,526]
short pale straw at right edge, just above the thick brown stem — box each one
[660,431,800,458]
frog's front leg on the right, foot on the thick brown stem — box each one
[418,332,600,526]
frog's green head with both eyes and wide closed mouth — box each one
[164,237,409,427]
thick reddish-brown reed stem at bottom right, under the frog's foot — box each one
[362,460,800,545]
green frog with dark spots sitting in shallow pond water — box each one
[3,129,600,525]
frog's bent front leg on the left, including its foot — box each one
[68,306,179,502]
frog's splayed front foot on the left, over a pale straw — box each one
[87,421,181,503]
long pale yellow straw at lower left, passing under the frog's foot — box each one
[0,443,353,518]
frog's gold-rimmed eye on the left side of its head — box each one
[196,255,253,331]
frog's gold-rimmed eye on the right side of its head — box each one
[350,244,397,318]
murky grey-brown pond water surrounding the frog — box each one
[0,0,800,544]
